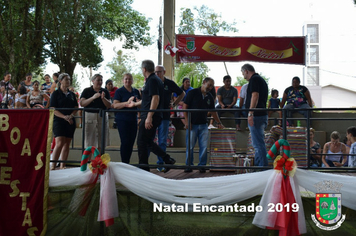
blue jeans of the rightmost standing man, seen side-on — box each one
[248,115,268,166]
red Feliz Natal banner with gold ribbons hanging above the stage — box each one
[176,34,305,65]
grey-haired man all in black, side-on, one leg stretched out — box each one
[136,60,176,172]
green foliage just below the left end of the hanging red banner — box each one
[174,63,209,88]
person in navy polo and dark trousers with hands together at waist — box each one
[111,73,141,164]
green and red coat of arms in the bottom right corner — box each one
[311,180,346,231]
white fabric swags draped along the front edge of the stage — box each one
[49,162,356,210]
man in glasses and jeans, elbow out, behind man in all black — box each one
[155,65,185,172]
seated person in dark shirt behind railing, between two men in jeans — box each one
[210,75,241,131]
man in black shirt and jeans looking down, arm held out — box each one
[183,77,224,173]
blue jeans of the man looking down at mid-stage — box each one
[185,124,209,166]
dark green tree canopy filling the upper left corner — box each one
[0,0,151,85]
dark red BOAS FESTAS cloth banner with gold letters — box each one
[0,109,53,236]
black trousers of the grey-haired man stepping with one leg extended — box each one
[137,116,166,171]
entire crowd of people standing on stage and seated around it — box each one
[0,60,356,173]
